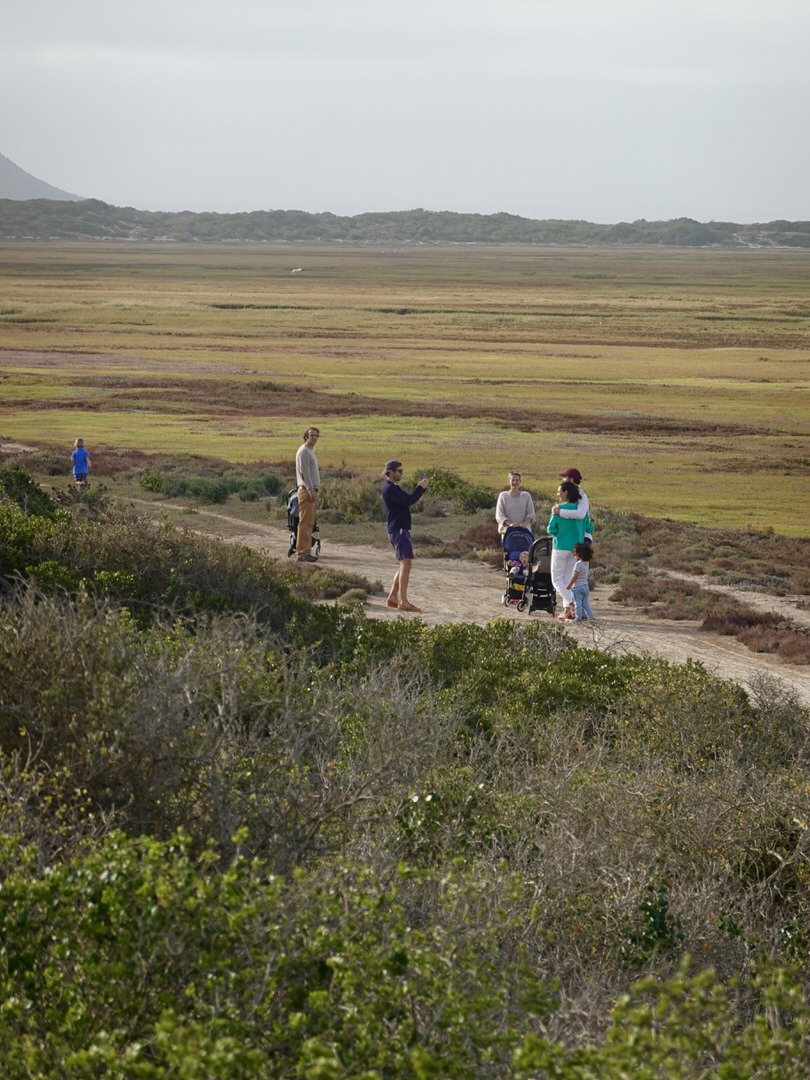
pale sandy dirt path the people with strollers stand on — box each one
[139,500,810,706]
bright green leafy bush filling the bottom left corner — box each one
[0,835,553,1078]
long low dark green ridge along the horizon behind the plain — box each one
[0,193,810,248]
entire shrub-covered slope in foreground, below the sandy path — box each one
[0,466,810,1080]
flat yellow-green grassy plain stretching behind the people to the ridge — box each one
[0,242,810,536]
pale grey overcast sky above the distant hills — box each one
[0,0,810,224]
